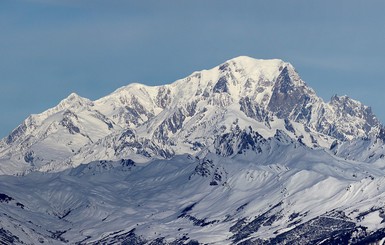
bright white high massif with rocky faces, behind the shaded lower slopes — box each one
[0,56,382,174]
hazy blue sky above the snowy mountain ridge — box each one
[0,0,385,137]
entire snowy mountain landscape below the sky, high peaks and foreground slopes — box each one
[0,56,385,245]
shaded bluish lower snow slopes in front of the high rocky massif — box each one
[0,137,385,244]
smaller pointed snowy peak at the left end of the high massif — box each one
[0,94,120,174]
